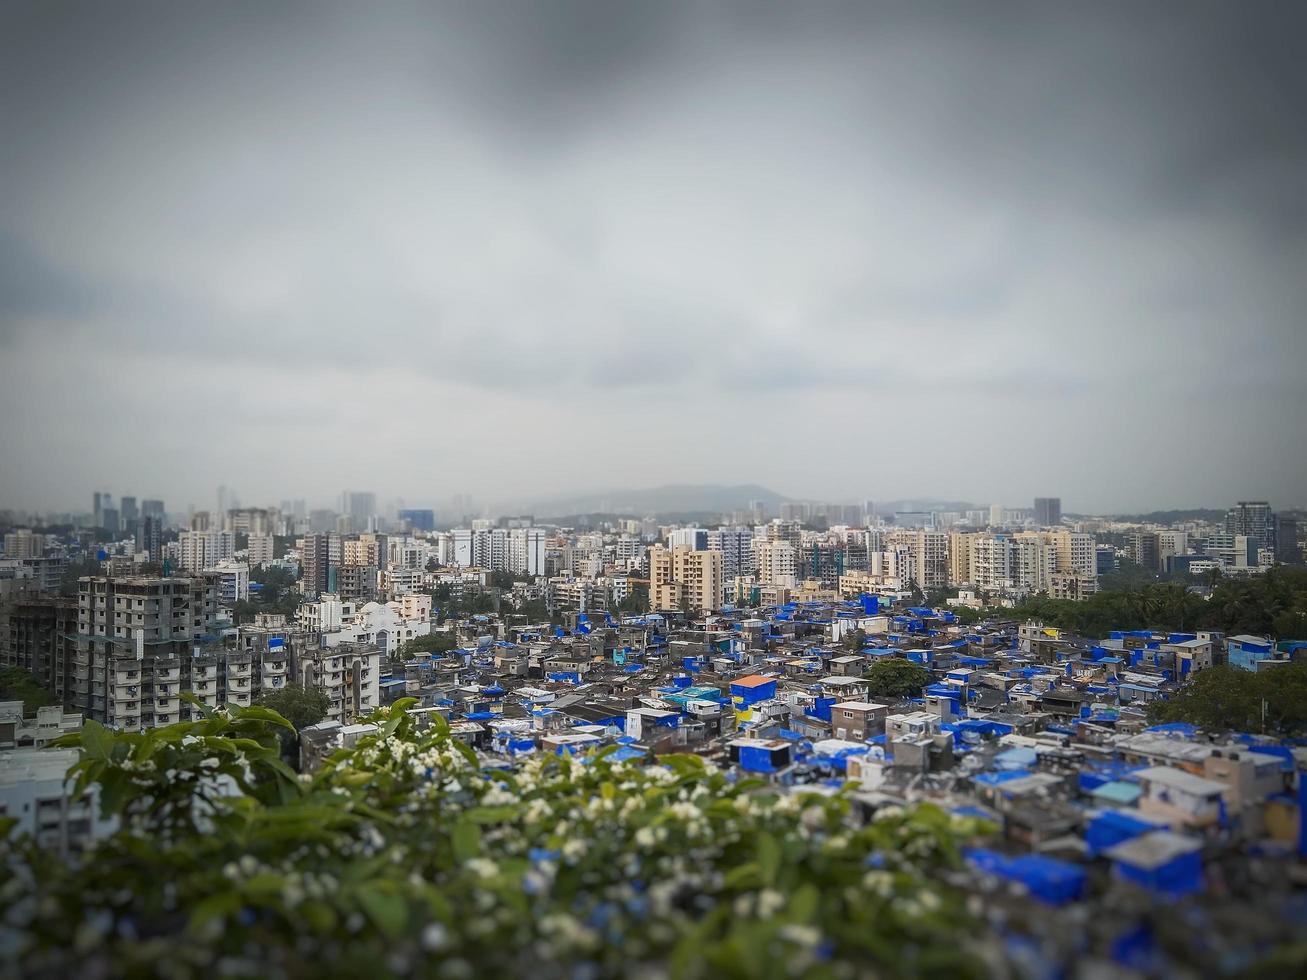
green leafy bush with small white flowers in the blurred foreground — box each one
[0,702,980,977]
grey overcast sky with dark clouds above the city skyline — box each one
[0,0,1307,511]
